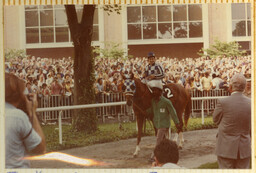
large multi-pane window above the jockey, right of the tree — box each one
[127,4,203,40]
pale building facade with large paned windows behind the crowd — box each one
[4,3,251,58]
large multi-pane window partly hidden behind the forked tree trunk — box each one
[25,5,99,44]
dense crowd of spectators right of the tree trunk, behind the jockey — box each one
[95,56,251,95]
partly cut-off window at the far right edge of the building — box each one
[231,3,251,37]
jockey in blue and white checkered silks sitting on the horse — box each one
[143,52,165,92]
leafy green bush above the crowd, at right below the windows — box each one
[198,39,246,58]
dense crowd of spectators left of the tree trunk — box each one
[5,56,74,97]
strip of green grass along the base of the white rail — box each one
[42,117,216,152]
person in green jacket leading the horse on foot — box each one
[146,83,180,161]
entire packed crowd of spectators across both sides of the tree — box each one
[5,56,251,99]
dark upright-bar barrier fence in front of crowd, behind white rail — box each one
[38,90,229,122]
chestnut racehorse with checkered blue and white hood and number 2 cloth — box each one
[122,75,192,157]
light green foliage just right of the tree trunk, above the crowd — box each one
[93,42,130,60]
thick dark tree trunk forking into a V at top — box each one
[65,5,97,133]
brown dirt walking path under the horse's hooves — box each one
[31,129,217,168]
